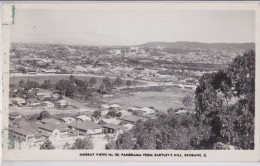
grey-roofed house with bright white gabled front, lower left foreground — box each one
[39,123,70,138]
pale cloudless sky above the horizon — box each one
[11,9,255,46]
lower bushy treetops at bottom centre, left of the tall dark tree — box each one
[106,114,203,150]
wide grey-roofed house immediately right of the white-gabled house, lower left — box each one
[69,120,102,135]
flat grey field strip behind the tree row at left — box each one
[9,74,144,87]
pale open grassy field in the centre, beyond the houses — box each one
[100,87,194,112]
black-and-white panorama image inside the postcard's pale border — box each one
[2,1,259,160]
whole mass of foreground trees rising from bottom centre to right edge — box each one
[106,51,255,150]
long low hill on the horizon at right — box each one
[139,41,255,50]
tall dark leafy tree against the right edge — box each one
[195,50,255,149]
